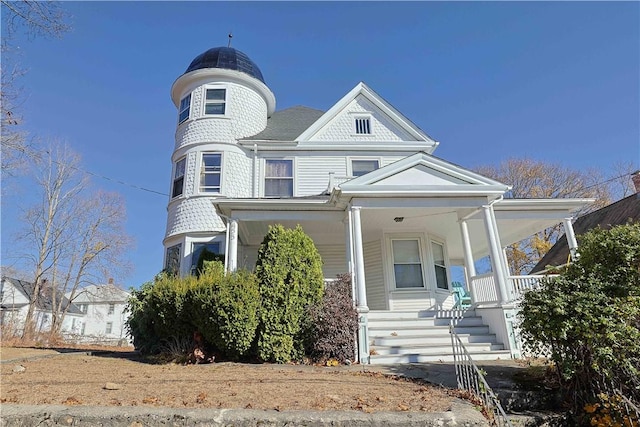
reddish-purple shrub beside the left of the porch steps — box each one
[307,274,358,362]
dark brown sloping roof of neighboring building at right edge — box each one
[531,193,640,274]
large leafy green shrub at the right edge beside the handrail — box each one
[520,224,640,422]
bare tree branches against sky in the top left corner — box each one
[0,0,69,177]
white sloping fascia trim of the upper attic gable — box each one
[296,82,438,147]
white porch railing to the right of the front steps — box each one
[471,273,557,304]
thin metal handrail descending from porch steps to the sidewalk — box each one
[449,318,513,427]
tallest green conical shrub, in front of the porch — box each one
[256,225,324,363]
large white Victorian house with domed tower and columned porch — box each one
[164,47,591,363]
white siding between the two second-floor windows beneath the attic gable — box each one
[296,156,347,196]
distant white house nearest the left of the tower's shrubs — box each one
[67,283,130,344]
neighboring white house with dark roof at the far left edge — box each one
[0,277,84,342]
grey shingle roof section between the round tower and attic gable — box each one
[242,105,324,141]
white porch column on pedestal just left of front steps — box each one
[351,206,369,363]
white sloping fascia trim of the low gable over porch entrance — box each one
[341,152,511,192]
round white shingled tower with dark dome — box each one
[163,47,275,275]
